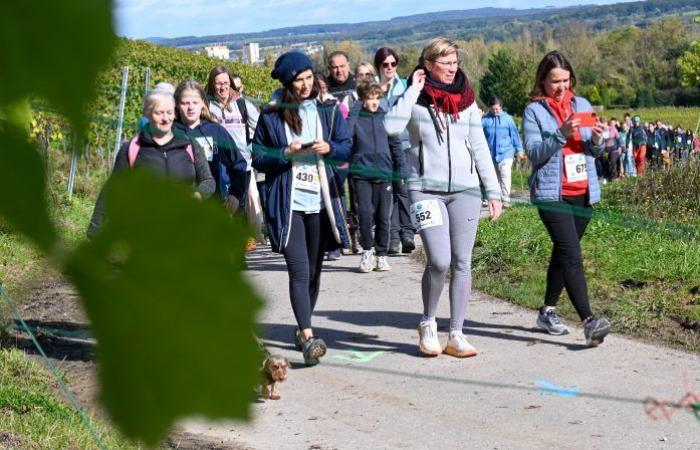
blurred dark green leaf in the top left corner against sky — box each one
[0,0,116,131]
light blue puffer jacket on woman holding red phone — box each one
[523,97,605,204]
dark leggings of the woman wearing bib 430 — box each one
[283,211,331,330]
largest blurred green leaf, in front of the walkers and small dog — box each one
[66,171,262,444]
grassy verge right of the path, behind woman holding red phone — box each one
[473,166,700,351]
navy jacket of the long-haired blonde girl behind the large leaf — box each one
[174,120,247,202]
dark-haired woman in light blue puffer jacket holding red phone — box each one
[523,51,610,346]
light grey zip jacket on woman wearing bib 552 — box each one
[384,86,501,200]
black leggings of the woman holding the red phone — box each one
[538,195,593,320]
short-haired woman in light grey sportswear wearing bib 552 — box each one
[384,38,502,357]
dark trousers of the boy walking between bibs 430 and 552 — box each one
[353,178,394,256]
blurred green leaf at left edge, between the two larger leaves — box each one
[0,129,56,252]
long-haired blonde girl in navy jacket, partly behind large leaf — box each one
[174,80,248,209]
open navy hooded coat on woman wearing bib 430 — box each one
[253,102,352,253]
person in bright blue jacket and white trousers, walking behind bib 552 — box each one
[481,97,524,207]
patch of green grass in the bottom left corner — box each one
[0,349,139,449]
